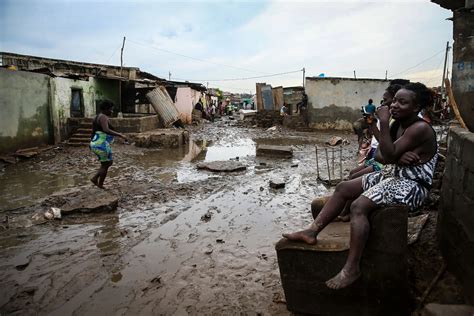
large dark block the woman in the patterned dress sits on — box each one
[275,207,409,315]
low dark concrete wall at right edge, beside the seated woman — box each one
[438,128,474,305]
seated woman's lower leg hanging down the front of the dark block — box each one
[326,196,378,290]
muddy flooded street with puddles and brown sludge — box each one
[0,119,357,315]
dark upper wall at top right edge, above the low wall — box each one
[452,10,474,132]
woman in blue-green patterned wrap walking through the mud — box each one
[89,100,127,189]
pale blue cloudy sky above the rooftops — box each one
[0,0,452,92]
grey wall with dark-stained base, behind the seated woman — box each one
[305,77,389,130]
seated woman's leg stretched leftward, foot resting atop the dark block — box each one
[283,178,363,245]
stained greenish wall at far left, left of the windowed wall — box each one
[0,69,53,152]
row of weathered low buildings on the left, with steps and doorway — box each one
[0,52,206,152]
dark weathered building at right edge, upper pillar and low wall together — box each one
[432,0,474,305]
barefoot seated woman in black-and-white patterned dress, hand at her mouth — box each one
[283,83,438,289]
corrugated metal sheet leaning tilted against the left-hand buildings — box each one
[146,86,179,127]
